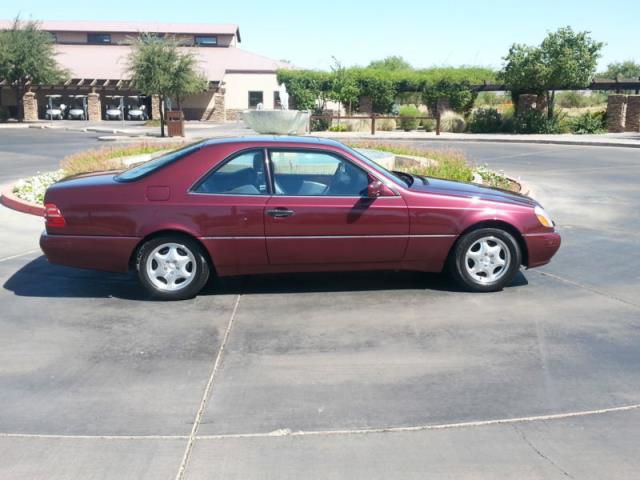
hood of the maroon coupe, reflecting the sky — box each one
[410,178,538,207]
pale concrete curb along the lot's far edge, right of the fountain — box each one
[324,135,640,148]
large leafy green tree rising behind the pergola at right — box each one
[500,27,604,118]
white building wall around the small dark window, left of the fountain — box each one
[223,73,278,110]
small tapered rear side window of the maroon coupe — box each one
[193,150,267,195]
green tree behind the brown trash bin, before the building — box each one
[128,34,207,137]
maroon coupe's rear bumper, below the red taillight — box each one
[40,232,140,272]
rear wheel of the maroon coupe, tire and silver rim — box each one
[136,235,210,300]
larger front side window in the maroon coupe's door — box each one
[270,150,369,197]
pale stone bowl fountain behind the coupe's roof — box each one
[242,83,310,135]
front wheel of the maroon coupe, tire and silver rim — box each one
[449,228,522,292]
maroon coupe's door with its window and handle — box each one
[265,148,409,265]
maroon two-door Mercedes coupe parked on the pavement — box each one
[40,137,560,299]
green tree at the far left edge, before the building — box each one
[0,17,68,121]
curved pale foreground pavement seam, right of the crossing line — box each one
[196,404,640,440]
